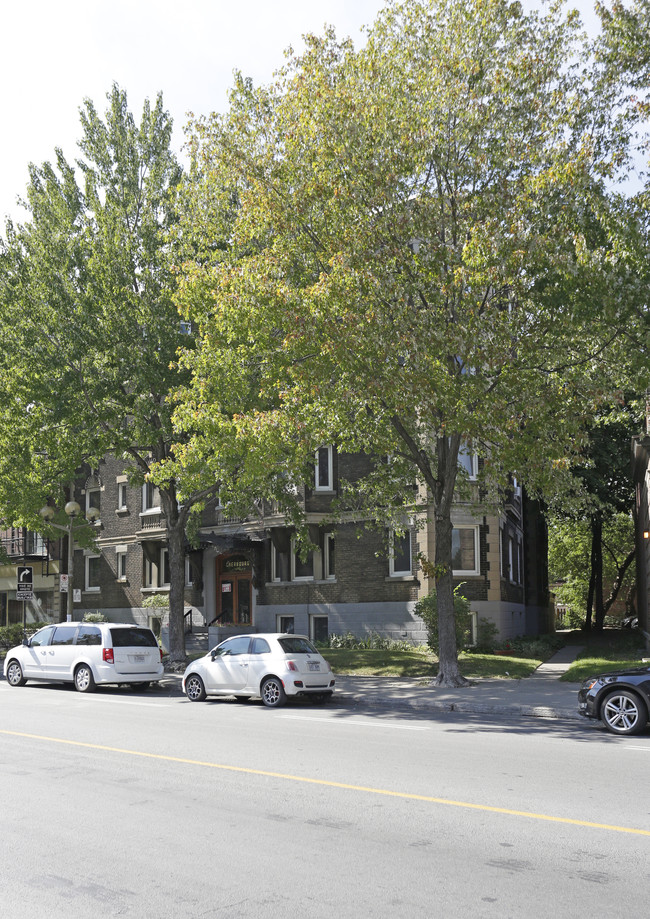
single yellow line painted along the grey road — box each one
[5,729,650,836]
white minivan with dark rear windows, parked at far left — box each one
[4,622,164,692]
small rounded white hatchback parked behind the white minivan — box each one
[183,633,335,708]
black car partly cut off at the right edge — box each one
[578,667,650,734]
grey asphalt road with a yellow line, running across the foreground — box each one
[0,682,650,919]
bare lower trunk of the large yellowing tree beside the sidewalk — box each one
[435,511,469,687]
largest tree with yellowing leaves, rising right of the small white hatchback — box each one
[173,0,644,685]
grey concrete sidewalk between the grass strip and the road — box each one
[161,645,582,720]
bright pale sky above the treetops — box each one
[0,0,604,228]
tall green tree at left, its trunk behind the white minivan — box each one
[0,86,214,658]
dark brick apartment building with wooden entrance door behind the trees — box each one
[24,447,553,643]
